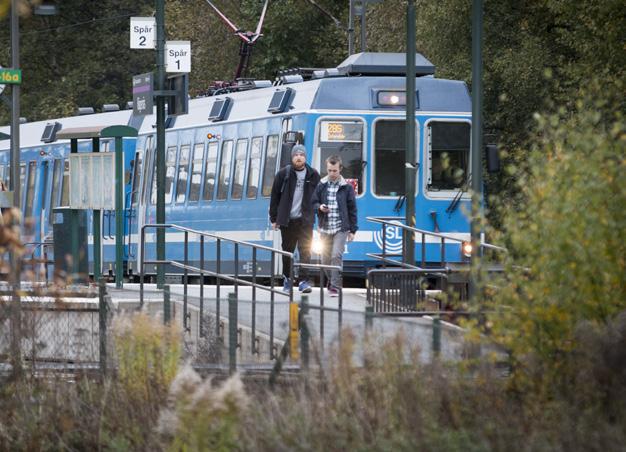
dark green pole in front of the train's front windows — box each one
[403,0,417,265]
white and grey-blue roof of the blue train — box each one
[0,54,471,150]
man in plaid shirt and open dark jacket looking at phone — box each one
[311,155,359,297]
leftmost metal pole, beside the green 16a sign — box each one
[9,0,22,379]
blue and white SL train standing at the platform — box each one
[0,53,471,276]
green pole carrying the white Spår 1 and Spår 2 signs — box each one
[156,0,165,288]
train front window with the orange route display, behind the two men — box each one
[319,119,363,193]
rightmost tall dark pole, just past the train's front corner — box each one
[469,0,483,300]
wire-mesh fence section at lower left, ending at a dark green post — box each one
[0,281,111,376]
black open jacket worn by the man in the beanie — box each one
[270,165,320,226]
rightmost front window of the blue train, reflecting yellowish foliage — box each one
[427,121,471,191]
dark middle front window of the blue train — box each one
[374,120,406,196]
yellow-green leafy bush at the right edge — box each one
[476,81,626,398]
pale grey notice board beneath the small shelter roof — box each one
[70,152,117,210]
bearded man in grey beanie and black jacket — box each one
[270,144,320,293]
